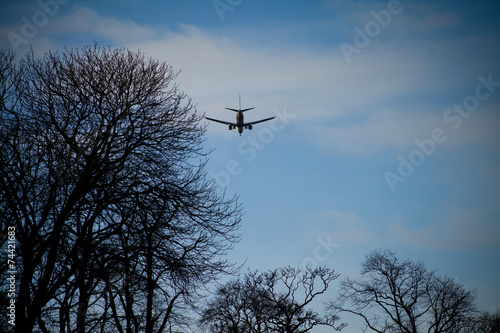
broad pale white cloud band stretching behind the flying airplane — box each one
[5,4,498,154]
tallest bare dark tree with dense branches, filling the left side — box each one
[0,46,241,332]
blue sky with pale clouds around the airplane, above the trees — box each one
[0,0,500,333]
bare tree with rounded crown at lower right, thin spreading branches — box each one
[330,250,476,333]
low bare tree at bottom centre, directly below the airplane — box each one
[200,267,342,333]
